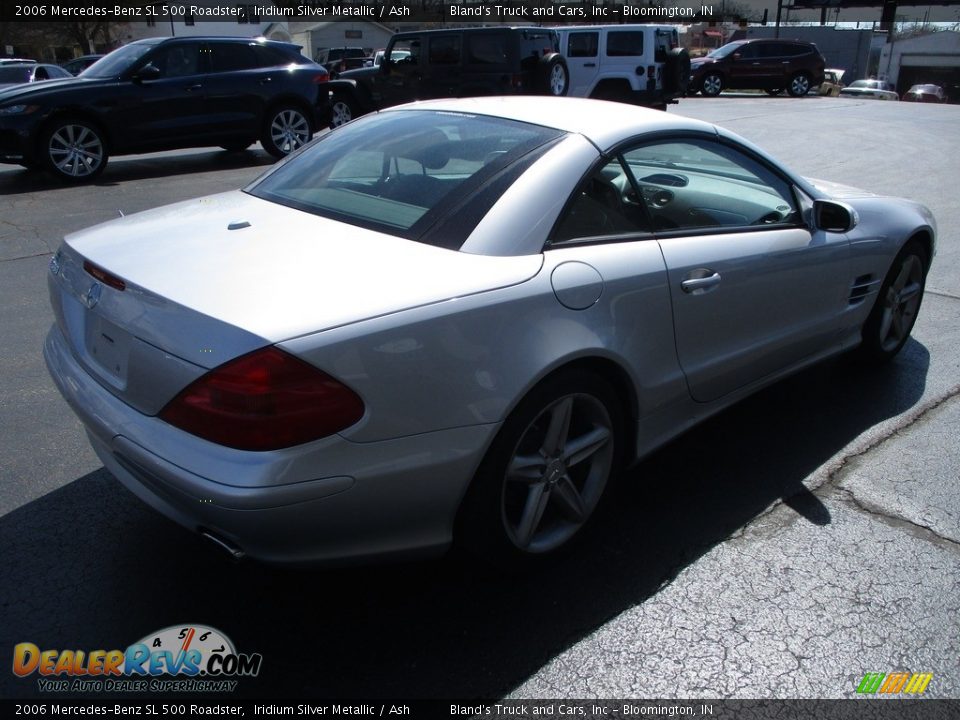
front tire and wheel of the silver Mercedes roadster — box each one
[858,240,929,364]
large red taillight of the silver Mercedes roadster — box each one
[160,347,364,450]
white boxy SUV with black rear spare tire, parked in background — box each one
[557,25,690,110]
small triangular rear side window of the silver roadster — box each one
[551,160,649,244]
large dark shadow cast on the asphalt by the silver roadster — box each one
[0,340,929,699]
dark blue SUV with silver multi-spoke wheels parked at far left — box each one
[0,37,329,182]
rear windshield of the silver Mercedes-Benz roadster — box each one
[246,111,563,245]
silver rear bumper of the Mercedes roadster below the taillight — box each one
[44,326,498,564]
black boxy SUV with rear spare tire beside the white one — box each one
[329,27,570,127]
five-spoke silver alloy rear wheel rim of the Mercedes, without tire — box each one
[501,393,614,553]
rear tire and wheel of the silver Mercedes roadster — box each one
[456,369,623,569]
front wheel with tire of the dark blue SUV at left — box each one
[38,117,110,183]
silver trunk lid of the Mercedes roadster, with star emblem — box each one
[51,191,542,414]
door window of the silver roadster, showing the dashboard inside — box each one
[623,139,800,231]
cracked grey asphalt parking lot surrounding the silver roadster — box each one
[0,96,960,698]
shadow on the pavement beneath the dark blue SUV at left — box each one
[0,150,276,196]
